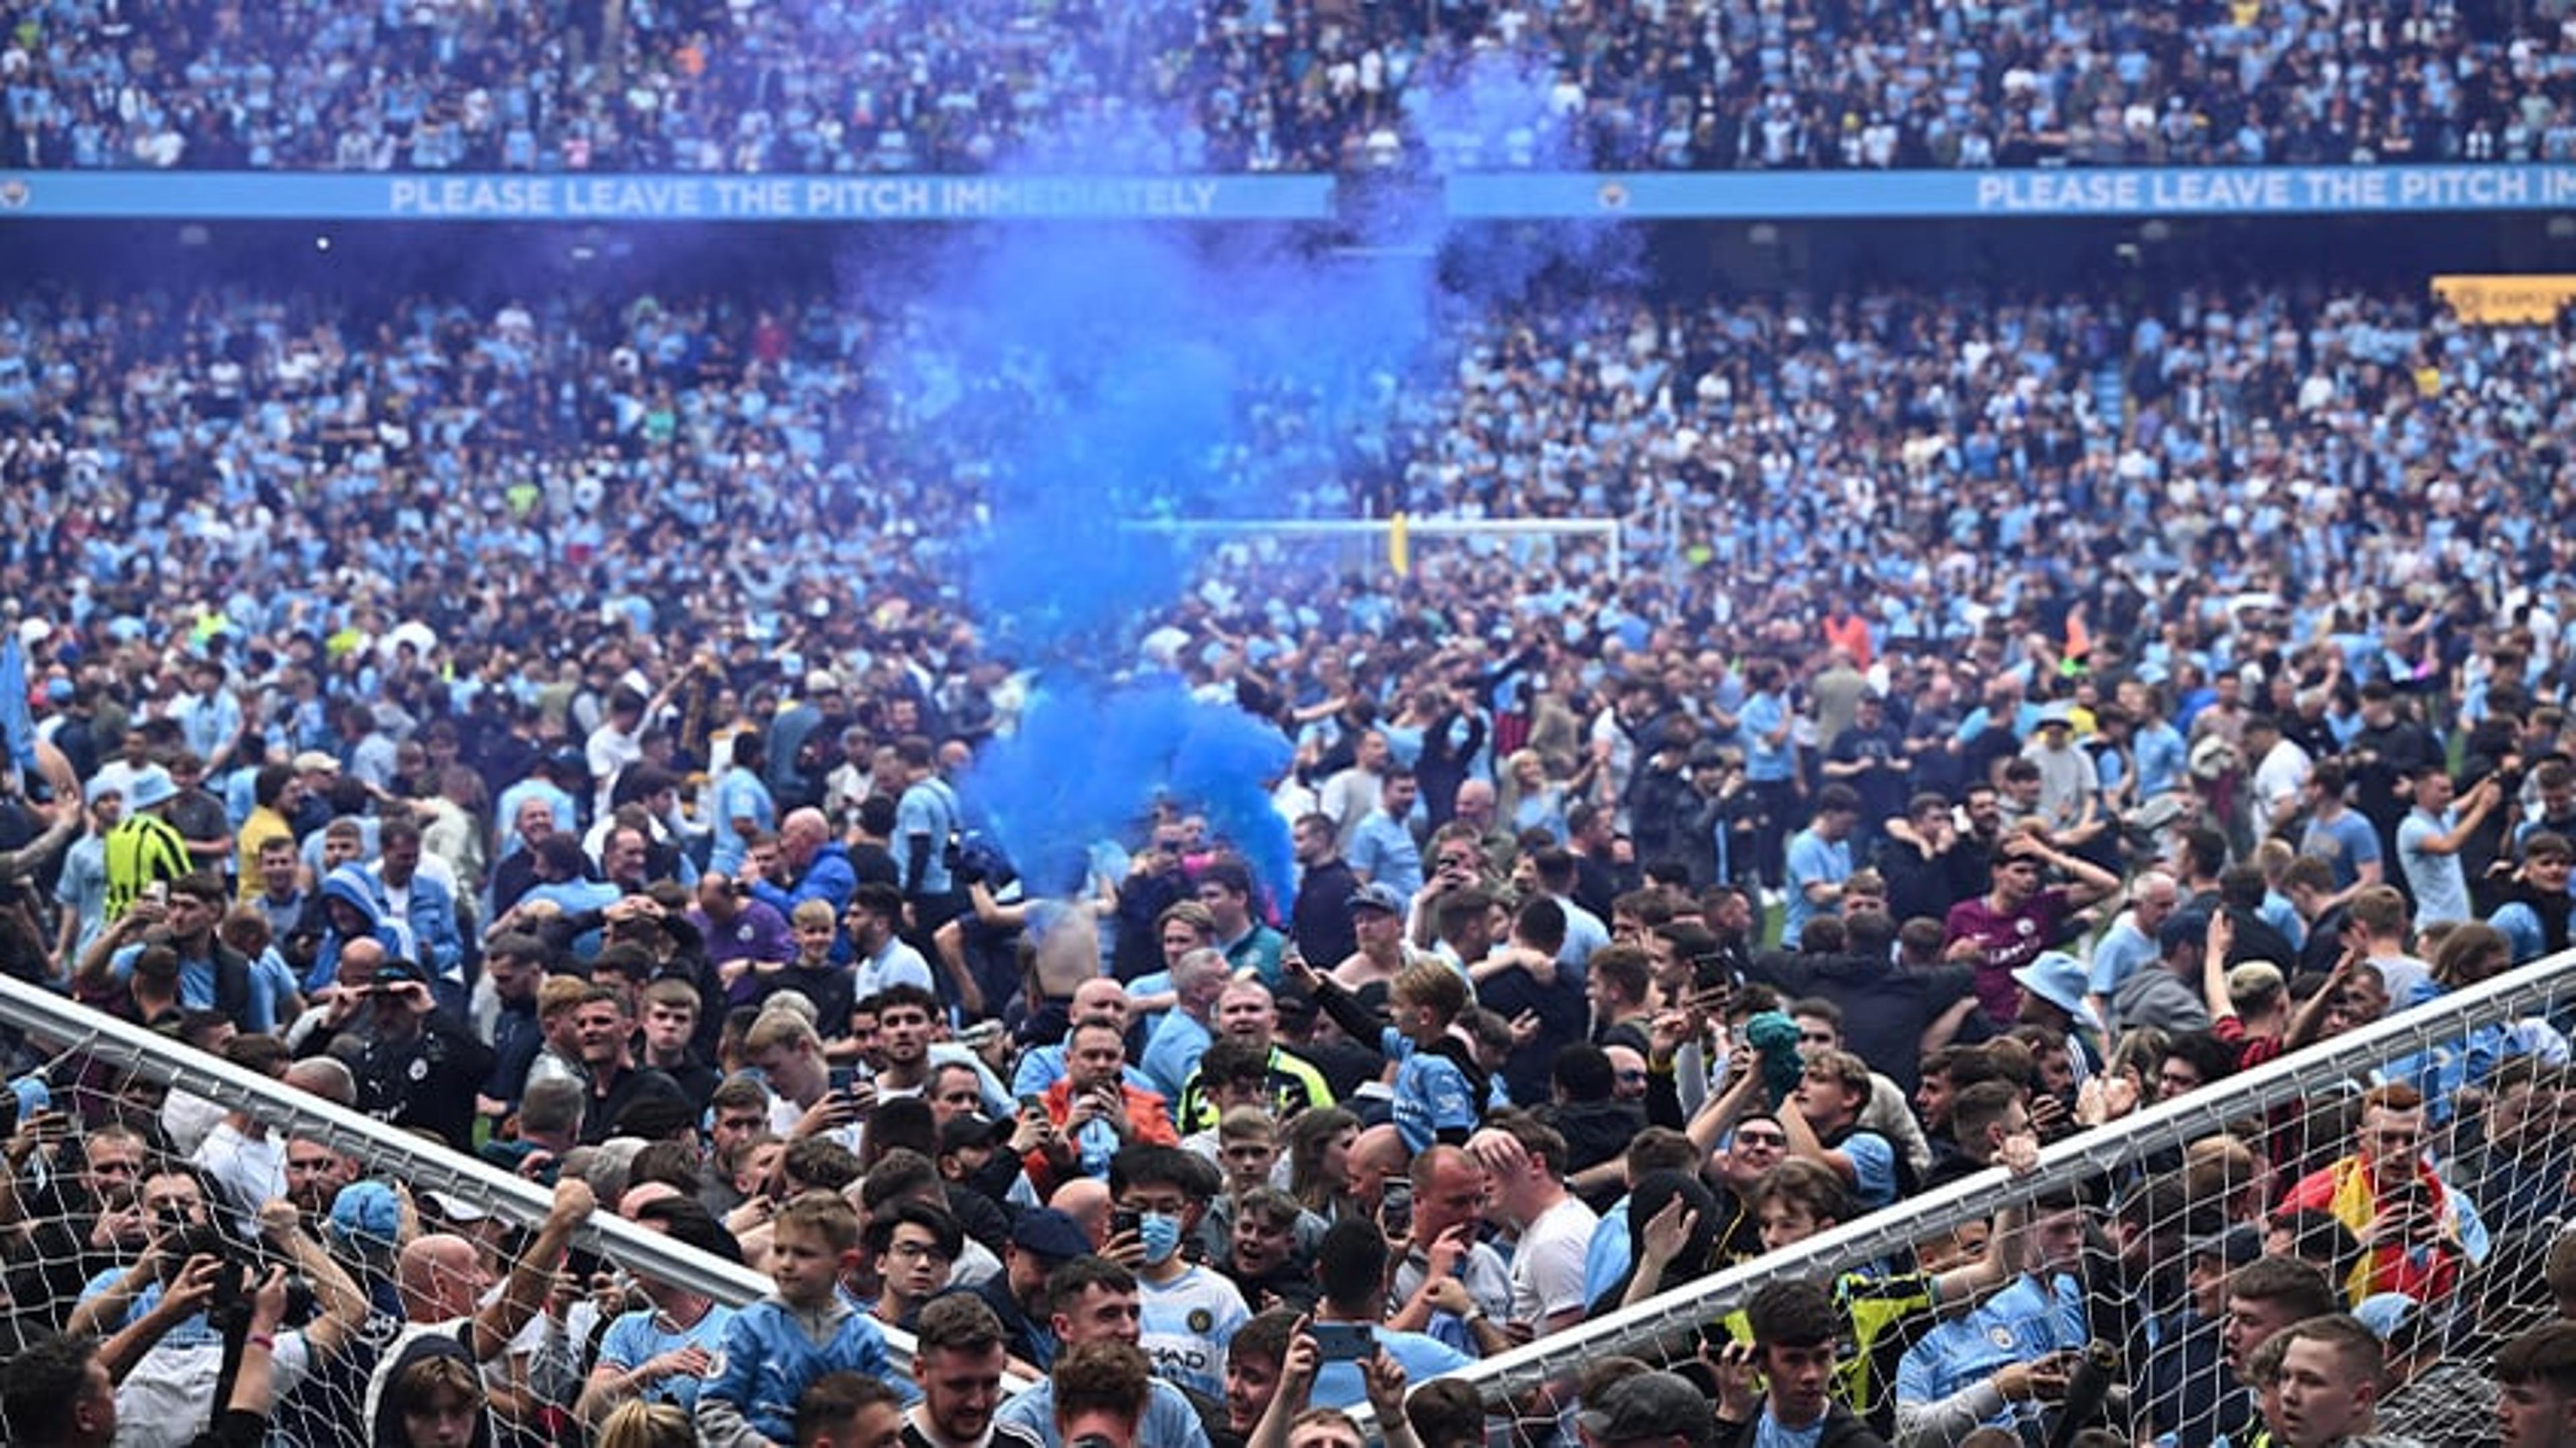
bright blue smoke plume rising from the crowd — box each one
[850,67,1627,904]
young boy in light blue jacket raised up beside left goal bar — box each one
[698,1190,920,1448]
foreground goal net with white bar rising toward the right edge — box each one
[1411,953,2576,1448]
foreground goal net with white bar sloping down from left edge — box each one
[0,979,989,1443]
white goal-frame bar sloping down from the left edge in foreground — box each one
[0,976,1025,1414]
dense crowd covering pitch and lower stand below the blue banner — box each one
[0,273,2576,1448]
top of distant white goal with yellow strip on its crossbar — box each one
[1120,515,1623,582]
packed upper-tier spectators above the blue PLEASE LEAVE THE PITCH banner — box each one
[15,0,2576,172]
